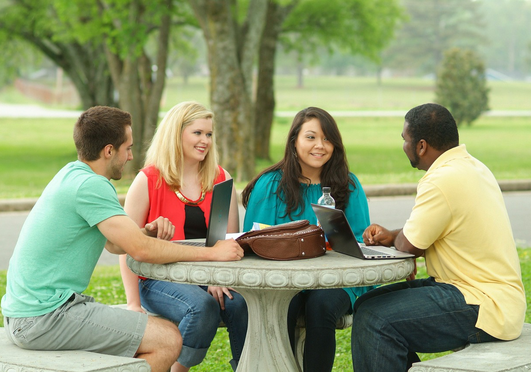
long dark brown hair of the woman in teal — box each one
[242,107,356,217]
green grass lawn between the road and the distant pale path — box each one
[0,117,531,199]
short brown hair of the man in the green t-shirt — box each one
[74,106,132,161]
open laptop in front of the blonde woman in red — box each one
[173,178,233,247]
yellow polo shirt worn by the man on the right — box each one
[403,145,526,340]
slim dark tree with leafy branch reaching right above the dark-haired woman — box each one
[255,0,402,159]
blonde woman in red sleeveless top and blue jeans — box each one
[120,102,247,372]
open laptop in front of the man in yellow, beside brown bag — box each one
[312,204,415,260]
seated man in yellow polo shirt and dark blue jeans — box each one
[352,103,526,372]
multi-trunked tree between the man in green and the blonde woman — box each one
[91,0,173,173]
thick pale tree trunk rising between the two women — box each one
[189,0,267,181]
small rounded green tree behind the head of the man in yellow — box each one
[435,48,489,125]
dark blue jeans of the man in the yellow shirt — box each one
[351,278,497,372]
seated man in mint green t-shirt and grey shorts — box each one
[2,106,243,371]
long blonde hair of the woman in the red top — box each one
[144,101,219,192]
